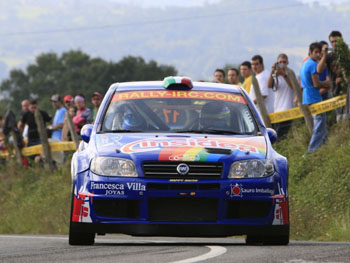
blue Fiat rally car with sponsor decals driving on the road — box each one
[69,77,289,245]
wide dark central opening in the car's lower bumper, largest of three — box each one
[148,197,218,222]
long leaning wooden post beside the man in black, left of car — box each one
[34,109,53,170]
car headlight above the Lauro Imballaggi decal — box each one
[228,159,275,179]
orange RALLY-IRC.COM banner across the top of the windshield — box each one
[112,90,247,104]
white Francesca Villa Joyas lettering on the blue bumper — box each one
[90,182,146,195]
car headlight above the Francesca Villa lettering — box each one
[90,156,137,177]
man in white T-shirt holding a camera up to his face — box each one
[267,54,295,138]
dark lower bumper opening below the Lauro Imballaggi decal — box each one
[227,200,272,219]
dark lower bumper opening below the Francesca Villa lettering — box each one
[93,199,140,218]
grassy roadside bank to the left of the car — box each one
[0,160,71,234]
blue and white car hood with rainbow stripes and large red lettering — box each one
[95,133,266,161]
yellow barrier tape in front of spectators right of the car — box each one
[269,95,346,123]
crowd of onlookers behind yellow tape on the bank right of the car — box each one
[214,31,349,153]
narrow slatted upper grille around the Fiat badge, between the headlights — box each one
[142,162,223,179]
